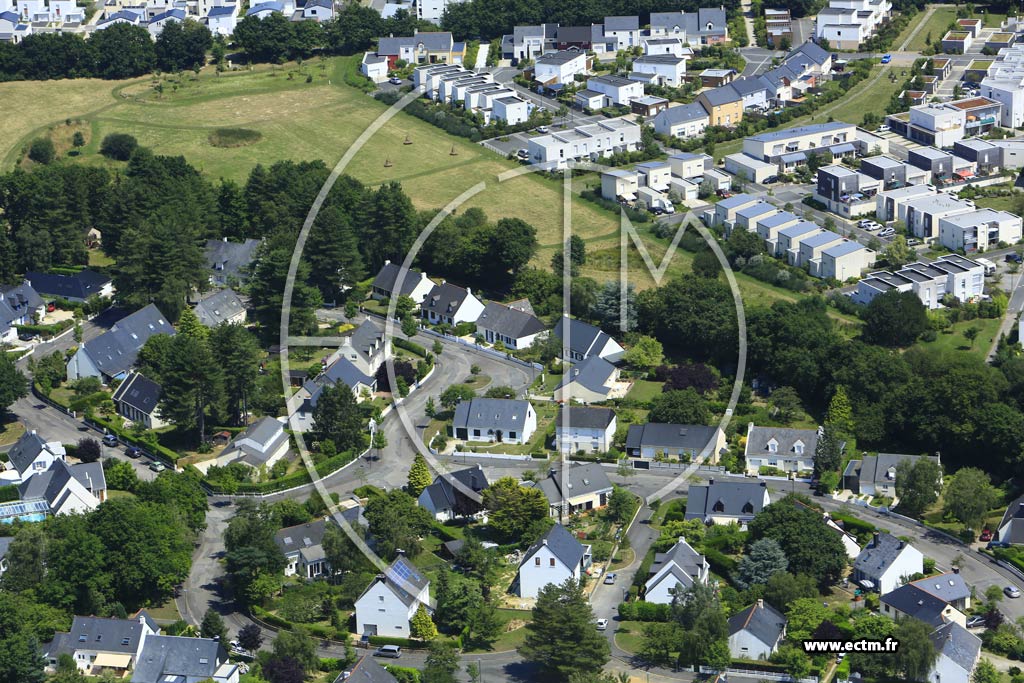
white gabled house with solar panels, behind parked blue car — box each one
[355,555,430,638]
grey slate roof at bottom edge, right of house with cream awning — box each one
[131,636,234,683]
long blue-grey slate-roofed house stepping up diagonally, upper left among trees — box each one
[68,303,174,382]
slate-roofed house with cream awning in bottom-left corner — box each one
[42,610,160,677]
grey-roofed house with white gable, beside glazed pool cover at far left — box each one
[17,460,106,515]
